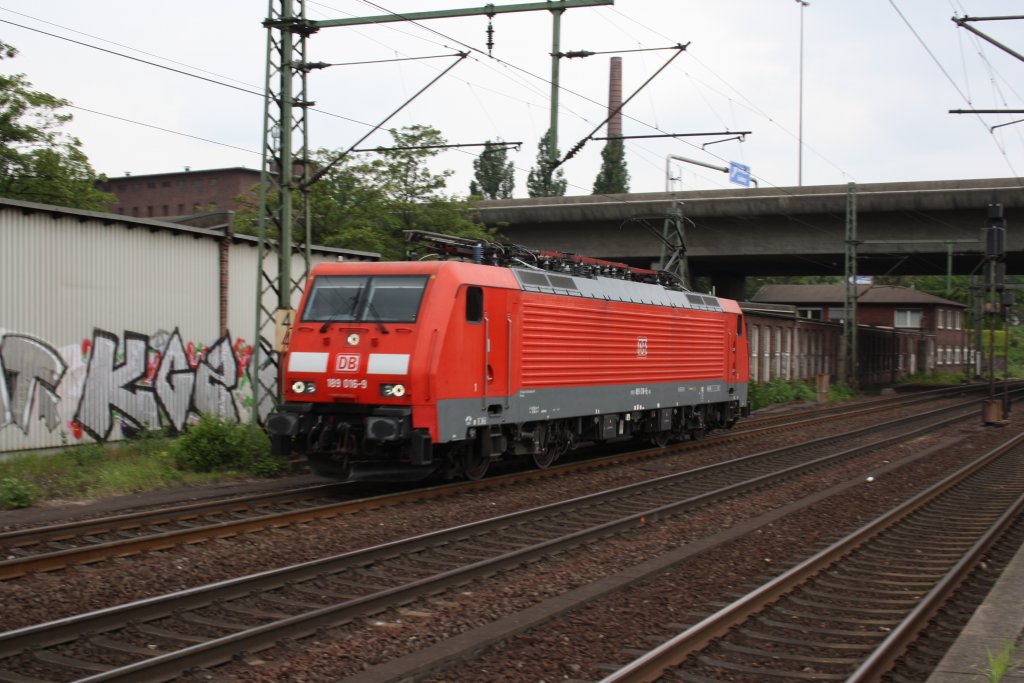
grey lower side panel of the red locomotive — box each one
[437,380,746,443]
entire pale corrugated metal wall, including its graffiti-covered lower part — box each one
[0,200,370,454]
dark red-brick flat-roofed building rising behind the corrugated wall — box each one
[96,167,260,218]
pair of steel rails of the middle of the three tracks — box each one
[0,401,987,681]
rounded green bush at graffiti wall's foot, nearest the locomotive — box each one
[171,415,283,476]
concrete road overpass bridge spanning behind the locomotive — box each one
[478,178,1024,298]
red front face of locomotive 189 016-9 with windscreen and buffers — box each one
[267,265,432,476]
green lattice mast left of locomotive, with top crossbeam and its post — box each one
[250,0,615,425]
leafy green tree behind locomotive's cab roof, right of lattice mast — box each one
[236,125,493,260]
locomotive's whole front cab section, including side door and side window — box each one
[266,261,515,480]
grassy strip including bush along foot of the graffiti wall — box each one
[0,416,283,509]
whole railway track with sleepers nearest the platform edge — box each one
[602,435,1024,683]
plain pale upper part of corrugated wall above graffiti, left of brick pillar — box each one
[0,211,218,343]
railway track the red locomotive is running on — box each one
[0,387,978,581]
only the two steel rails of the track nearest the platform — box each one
[600,434,1024,683]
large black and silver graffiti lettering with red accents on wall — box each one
[0,329,252,441]
